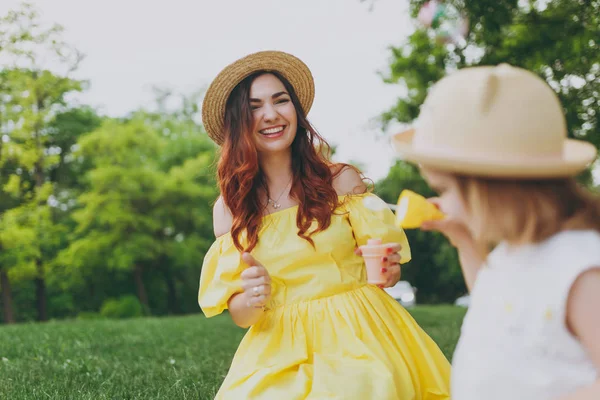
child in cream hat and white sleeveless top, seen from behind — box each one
[393,65,600,400]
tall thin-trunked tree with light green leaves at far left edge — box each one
[0,4,82,321]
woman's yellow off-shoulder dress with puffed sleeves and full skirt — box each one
[198,194,450,400]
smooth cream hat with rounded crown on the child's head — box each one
[392,64,596,179]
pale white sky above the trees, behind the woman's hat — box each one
[0,0,412,180]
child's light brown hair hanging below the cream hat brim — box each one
[455,175,600,247]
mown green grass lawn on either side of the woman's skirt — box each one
[0,306,464,400]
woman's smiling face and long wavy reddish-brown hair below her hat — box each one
[218,65,340,251]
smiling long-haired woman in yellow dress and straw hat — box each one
[199,52,450,400]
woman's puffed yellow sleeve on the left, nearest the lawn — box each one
[198,234,244,317]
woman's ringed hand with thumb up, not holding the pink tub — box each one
[241,253,271,308]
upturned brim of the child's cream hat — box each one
[391,129,597,179]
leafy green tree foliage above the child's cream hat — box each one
[383,0,600,147]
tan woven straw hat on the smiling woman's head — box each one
[202,51,315,146]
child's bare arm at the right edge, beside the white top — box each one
[560,267,600,400]
